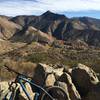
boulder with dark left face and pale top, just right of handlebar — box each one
[32,63,64,86]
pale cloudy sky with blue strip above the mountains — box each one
[0,0,100,18]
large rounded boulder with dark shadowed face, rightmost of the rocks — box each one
[69,64,99,96]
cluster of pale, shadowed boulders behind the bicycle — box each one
[0,63,100,100]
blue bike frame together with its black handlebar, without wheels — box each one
[3,65,54,100]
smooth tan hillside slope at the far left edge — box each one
[0,16,22,39]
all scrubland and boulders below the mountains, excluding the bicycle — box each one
[0,40,100,100]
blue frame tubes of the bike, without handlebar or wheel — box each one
[10,75,54,100]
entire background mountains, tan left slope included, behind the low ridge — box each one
[0,11,100,47]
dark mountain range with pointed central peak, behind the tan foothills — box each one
[10,11,100,46]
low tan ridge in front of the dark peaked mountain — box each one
[10,26,54,44]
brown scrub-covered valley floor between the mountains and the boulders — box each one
[0,41,100,79]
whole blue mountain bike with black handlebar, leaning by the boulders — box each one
[3,66,67,100]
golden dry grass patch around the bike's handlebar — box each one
[0,60,36,80]
